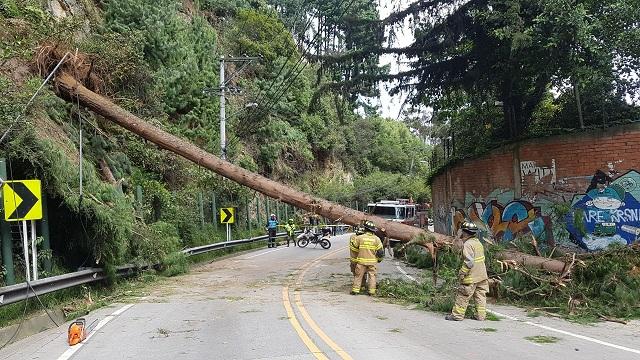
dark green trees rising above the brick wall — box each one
[314,0,640,167]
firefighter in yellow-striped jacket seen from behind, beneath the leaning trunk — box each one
[349,220,384,295]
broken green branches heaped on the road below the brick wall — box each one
[379,242,640,322]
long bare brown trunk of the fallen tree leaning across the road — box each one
[56,72,566,273]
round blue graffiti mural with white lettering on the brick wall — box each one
[567,171,640,251]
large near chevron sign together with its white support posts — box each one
[2,180,42,281]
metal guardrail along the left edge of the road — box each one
[0,233,286,306]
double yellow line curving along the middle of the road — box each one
[282,248,353,360]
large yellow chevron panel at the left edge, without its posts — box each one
[2,180,42,221]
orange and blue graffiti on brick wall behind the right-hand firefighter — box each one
[452,200,553,243]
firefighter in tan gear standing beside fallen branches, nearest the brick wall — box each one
[445,221,489,321]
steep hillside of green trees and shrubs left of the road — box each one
[0,0,429,283]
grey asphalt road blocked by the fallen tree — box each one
[0,236,640,360]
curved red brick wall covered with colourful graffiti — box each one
[432,124,640,248]
